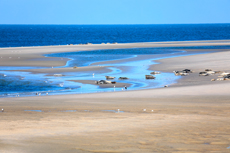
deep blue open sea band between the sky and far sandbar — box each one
[0,24,230,47]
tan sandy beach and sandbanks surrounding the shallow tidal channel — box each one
[0,40,230,153]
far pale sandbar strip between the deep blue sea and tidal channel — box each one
[0,40,230,67]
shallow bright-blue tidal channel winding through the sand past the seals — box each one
[0,49,199,97]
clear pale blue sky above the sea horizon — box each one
[0,0,230,24]
